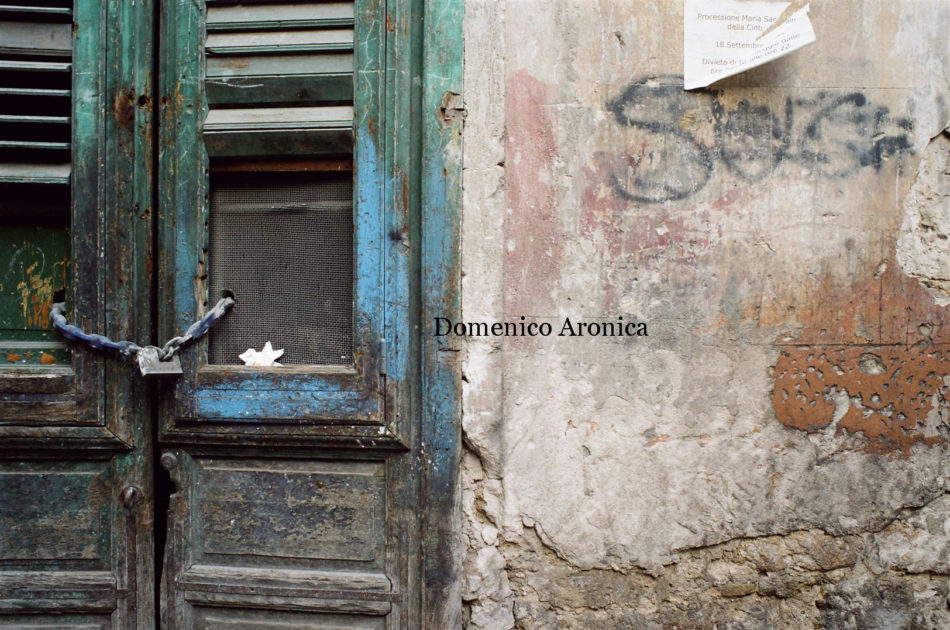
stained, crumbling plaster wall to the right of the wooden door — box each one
[458,0,950,628]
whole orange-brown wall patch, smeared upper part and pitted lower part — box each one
[760,235,950,457]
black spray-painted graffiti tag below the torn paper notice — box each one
[607,76,913,203]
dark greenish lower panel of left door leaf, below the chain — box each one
[0,457,153,628]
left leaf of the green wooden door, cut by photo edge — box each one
[0,0,156,629]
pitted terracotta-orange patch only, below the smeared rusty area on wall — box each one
[772,344,950,457]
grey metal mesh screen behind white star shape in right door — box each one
[208,173,353,365]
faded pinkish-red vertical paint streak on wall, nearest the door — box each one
[504,69,562,315]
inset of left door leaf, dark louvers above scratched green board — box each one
[0,0,72,365]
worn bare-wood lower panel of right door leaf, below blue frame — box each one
[163,450,397,628]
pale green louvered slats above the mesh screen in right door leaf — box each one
[204,0,353,159]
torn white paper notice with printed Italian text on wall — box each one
[683,0,815,90]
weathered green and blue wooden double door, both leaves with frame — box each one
[0,0,460,630]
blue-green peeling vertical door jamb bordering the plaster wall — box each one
[421,0,464,628]
